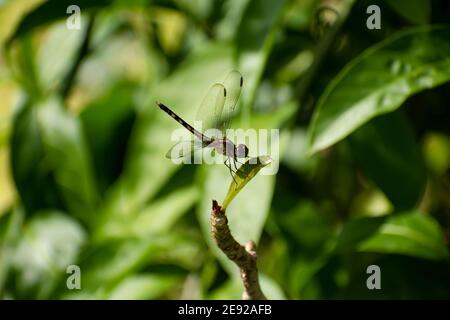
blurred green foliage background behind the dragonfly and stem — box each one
[0,0,450,299]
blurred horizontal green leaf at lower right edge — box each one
[337,212,448,260]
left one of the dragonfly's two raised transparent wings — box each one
[195,83,227,136]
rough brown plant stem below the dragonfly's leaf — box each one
[211,200,267,300]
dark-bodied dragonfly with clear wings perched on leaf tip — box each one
[156,71,249,182]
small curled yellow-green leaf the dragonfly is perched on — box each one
[222,156,272,209]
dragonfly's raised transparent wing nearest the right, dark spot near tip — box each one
[219,70,243,133]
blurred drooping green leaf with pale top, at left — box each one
[36,99,99,222]
